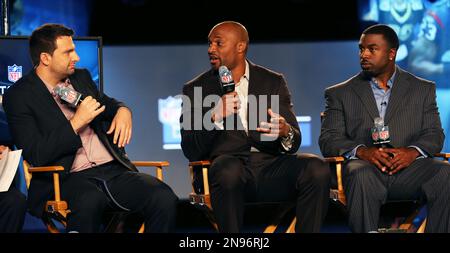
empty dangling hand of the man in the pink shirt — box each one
[107,107,133,148]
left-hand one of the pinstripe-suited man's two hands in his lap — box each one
[356,147,392,172]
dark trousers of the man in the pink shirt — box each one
[61,162,178,232]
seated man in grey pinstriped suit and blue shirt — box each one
[319,25,450,232]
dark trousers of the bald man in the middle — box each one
[209,153,330,232]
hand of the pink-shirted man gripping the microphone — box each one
[70,96,105,133]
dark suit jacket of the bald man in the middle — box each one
[180,62,301,161]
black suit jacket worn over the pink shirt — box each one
[3,69,136,217]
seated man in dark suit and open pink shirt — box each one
[3,24,177,232]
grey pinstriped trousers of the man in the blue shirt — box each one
[343,158,450,233]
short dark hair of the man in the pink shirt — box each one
[30,24,74,66]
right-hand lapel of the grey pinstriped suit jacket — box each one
[384,68,408,124]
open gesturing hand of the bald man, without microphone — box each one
[256,108,291,139]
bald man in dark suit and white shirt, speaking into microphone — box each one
[181,21,329,232]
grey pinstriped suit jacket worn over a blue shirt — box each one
[319,67,444,156]
